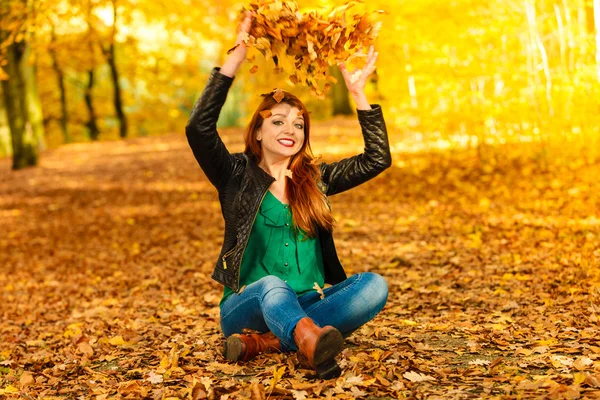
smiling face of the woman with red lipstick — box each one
[256,103,304,160]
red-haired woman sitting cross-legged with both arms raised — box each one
[186,14,391,379]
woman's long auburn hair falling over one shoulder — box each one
[244,92,334,238]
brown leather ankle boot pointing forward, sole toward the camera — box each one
[294,317,344,379]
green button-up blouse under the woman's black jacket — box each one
[220,190,325,304]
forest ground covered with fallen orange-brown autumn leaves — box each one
[0,121,600,400]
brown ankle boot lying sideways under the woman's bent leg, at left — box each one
[223,332,281,361]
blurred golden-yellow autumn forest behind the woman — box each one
[0,0,600,167]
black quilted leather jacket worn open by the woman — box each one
[185,68,392,292]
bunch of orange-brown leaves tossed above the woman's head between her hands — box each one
[242,0,381,96]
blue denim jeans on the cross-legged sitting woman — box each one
[221,272,388,351]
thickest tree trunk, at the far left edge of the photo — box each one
[2,41,44,170]
